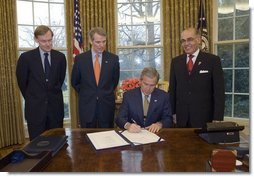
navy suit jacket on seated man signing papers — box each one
[116,88,172,128]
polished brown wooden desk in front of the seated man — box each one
[41,128,248,172]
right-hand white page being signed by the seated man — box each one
[121,129,165,145]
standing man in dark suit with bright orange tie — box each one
[71,27,120,128]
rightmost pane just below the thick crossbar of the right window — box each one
[235,43,250,67]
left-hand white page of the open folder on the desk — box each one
[87,130,130,150]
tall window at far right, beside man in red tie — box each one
[215,0,250,118]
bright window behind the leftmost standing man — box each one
[17,0,69,118]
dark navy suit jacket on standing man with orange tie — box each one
[71,50,120,127]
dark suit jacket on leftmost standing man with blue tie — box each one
[16,48,66,132]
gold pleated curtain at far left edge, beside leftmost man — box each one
[0,0,25,148]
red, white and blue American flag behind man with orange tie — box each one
[73,0,83,58]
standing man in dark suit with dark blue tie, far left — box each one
[16,25,66,140]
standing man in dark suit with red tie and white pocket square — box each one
[169,28,225,128]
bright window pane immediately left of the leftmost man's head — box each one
[18,25,36,48]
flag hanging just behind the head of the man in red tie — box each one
[198,0,209,52]
